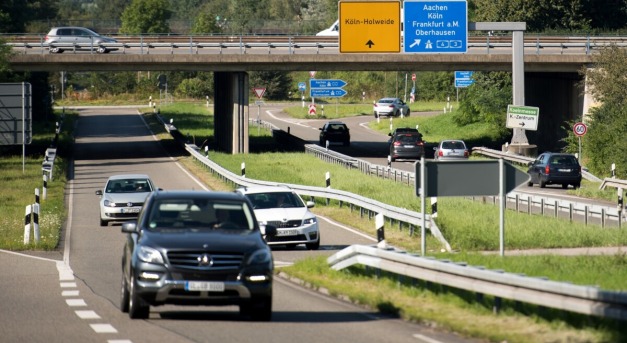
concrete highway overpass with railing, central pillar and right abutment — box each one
[3,31,604,153]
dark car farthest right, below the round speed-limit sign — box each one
[527,152,581,189]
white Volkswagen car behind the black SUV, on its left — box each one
[96,174,156,226]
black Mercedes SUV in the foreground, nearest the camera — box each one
[120,191,276,320]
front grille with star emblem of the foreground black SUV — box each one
[168,251,244,270]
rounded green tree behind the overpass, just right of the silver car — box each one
[120,0,171,35]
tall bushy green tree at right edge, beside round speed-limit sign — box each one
[582,46,627,179]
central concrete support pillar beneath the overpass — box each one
[213,72,249,154]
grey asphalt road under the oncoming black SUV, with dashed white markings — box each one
[0,109,478,343]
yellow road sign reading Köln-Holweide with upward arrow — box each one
[339,1,401,53]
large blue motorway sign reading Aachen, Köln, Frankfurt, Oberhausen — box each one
[403,0,468,53]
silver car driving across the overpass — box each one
[45,26,118,54]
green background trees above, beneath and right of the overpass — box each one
[0,0,627,178]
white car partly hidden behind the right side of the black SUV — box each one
[236,186,320,250]
